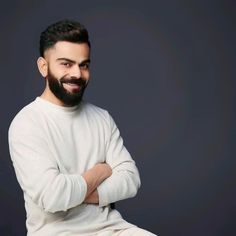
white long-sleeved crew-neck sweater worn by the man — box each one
[9,97,140,236]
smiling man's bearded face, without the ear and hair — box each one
[42,41,90,106]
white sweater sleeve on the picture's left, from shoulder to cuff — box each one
[9,116,87,212]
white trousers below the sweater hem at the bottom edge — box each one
[96,227,156,236]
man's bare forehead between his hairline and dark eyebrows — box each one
[45,41,90,63]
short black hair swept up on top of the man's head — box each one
[39,20,90,57]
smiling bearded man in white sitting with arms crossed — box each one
[9,20,157,236]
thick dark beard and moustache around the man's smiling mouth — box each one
[46,70,88,106]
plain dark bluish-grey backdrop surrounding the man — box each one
[0,0,236,236]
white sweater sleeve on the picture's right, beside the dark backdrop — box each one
[98,113,141,206]
